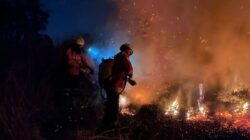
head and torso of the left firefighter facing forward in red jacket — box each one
[64,36,94,89]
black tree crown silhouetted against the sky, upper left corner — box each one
[0,0,48,45]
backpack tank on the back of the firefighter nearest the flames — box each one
[98,58,114,87]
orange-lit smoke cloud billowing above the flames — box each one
[109,0,250,107]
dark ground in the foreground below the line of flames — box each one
[38,105,250,140]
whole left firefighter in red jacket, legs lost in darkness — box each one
[55,36,94,125]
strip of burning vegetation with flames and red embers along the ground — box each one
[120,84,250,133]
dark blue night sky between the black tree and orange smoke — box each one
[41,0,117,40]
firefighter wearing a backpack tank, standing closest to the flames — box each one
[97,43,136,133]
